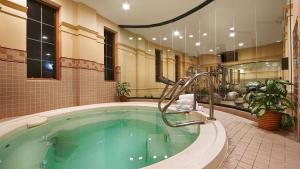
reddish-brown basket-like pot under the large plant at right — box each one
[257,112,281,130]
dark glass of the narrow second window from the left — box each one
[104,30,115,80]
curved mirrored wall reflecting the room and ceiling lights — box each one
[120,0,289,109]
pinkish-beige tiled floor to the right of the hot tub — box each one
[216,111,300,169]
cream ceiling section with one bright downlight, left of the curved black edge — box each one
[75,0,205,25]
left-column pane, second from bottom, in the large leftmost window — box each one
[27,39,41,60]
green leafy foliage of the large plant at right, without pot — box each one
[244,80,295,127]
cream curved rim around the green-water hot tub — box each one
[0,102,228,169]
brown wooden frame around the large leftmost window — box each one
[26,0,61,80]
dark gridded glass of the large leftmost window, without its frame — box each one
[27,0,56,79]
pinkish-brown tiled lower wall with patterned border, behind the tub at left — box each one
[0,48,116,119]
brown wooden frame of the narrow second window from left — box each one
[103,27,117,82]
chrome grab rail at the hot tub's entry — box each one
[158,72,215,127]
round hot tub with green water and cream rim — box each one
[0,103,227,169]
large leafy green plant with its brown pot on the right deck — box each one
[245,80,295,130]
